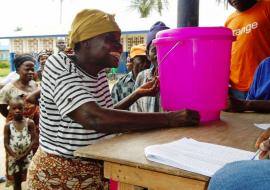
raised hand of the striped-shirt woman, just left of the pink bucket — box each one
[136,77,159,97]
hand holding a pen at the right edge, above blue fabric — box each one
[256,128,270,159]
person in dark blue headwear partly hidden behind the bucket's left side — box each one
[130,21,169,112]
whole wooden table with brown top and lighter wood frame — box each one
[75,113,270,190]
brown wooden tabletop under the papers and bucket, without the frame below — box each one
[74,112,270,181]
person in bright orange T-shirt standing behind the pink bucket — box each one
[225,0,270,99]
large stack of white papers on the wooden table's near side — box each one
[145,138,254,177]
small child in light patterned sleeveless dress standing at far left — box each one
[4,97,37,190]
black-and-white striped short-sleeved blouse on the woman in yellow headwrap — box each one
[39,53,113,158]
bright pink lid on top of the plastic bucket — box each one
[153,26,235,43]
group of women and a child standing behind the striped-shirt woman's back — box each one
[0,39,66,189]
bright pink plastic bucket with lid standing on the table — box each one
[153,27,234,122]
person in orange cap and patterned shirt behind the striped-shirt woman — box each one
[111,44,150,104]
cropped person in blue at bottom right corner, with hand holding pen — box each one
[208,123,270,190]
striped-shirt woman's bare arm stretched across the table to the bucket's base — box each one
[68,102,200,133]
